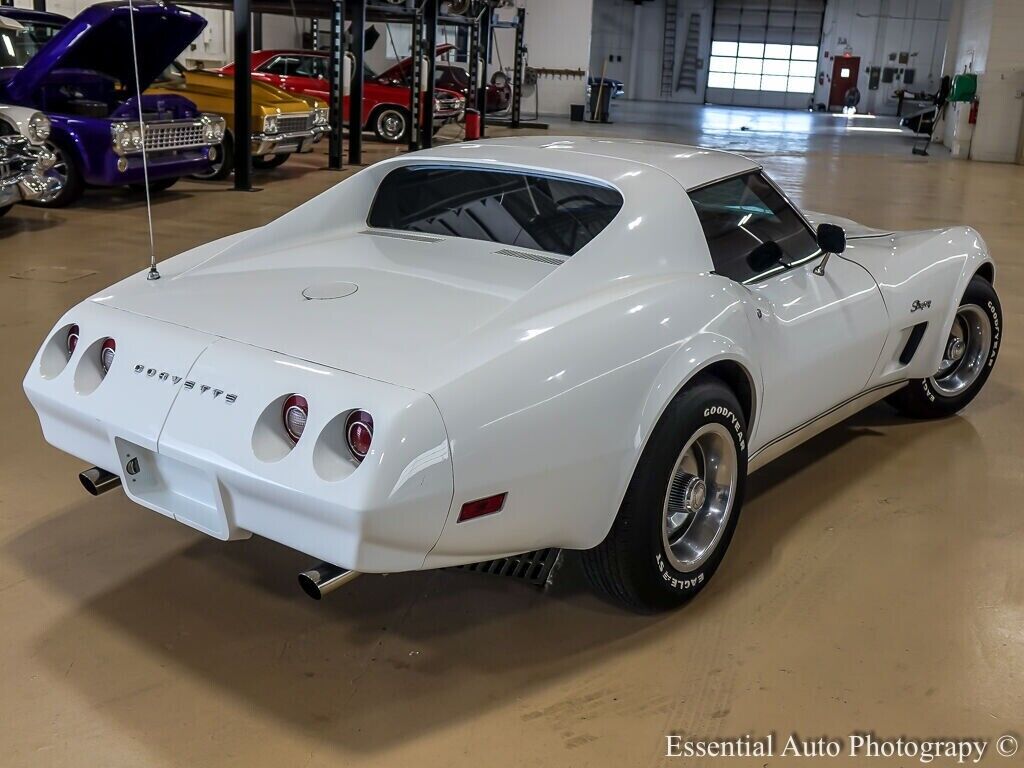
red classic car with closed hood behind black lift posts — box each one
[221,50,466,143]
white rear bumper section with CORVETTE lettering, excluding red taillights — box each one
[25,302,453,572]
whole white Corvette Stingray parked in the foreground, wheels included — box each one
[25,138,1001,610]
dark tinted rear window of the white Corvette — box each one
[367,166,623,256]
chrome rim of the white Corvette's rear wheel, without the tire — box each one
[662,424,738,573]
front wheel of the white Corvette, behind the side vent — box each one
[889,275,1002,419]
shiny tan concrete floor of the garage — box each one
[0,111,1024,768]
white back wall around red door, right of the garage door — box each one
[814,0,952,115]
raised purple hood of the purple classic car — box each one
[6,0,206,100]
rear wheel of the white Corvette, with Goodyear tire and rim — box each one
[582,377,746,611]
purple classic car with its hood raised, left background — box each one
[0,0,224,207]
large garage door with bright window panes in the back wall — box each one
[707,0,825,109]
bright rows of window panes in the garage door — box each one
[708,40,818,93]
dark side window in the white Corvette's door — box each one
[689,172,818,283]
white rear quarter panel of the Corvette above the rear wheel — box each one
[425,273,753,567]
